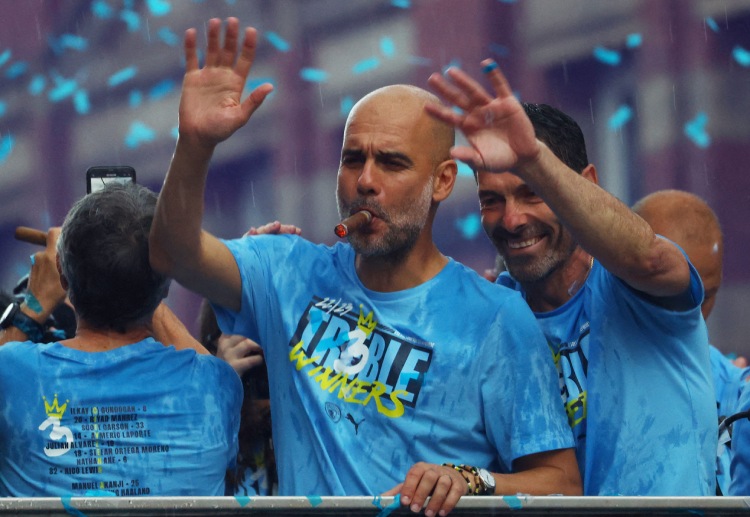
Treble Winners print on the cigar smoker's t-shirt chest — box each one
[289,297,432,418]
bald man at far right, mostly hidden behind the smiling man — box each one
[633,190,750,494]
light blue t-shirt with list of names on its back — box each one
[0,338,242,497]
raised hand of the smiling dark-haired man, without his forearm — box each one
[425,59,540,172]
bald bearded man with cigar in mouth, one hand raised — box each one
[150,18,581,516]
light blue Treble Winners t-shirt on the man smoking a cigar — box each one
[216,235,573,496]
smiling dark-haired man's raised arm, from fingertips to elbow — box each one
[426,60,690,297]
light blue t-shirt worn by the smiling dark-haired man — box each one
[498,256,718,496]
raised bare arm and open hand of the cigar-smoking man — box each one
[149,18,273,310]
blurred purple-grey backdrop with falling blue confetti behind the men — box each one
[0,0,750,355]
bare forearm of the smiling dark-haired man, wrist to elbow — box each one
[518,144,689,296]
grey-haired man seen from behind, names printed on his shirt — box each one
[0,185,242,497]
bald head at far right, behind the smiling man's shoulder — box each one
[633,190,724,318]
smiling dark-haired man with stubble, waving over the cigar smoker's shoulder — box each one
[426,60,718,496]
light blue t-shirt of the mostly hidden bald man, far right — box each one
[710,346,750,495]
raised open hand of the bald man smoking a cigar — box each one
[179,18,273,149]
